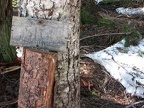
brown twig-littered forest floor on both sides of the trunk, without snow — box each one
[0,2,144,108]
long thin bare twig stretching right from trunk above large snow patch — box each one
[80,32,131,41]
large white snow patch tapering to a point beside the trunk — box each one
[85,39,144,98]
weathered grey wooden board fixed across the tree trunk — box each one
[10,16,69,51]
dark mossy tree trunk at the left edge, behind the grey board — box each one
[0,0,16,62]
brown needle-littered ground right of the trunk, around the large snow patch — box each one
[80,2,144,108]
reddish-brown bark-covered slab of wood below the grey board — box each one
[18,49,57,108]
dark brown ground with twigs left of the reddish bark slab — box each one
[0,60,20,108]
